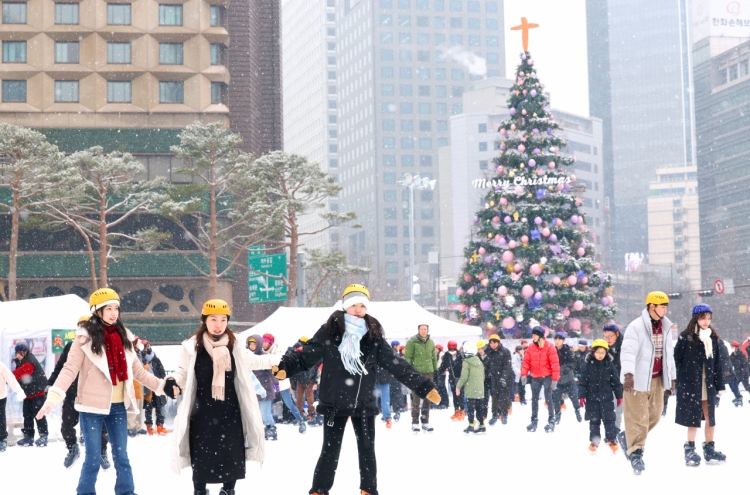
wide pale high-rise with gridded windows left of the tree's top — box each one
[331,0,505,297]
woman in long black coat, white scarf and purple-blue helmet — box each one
[674,304,726,465]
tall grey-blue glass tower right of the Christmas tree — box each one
[586,0,694,269]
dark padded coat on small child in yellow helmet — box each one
[578,354,622,421]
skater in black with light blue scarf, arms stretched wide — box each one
[276,284,440,495]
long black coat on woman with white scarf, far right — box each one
[674,331,724,428]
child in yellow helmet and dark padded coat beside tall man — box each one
[578,339,622,452]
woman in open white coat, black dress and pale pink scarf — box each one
[165,299,281,495]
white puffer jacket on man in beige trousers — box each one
[620,309,677,392]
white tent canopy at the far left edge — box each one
[0,294,91,375]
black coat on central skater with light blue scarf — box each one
[279,311,435,416]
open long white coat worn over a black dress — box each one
[168,337,281,474]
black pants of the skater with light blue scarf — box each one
[310,416,378,495]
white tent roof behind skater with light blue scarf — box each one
[241,301,482,349]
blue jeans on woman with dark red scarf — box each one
[76,402,135,495]
